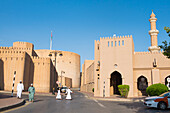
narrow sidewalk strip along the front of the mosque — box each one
[80,91,145,102]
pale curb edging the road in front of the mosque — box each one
[81,92,144,102]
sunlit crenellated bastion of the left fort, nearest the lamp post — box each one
[32,57,52,92]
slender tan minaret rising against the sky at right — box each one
[148,10,160,52]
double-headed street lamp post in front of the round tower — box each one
[49,50,63,95]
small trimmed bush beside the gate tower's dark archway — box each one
[118,85,129,98]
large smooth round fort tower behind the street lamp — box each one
[35,50,80,88]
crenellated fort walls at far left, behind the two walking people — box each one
[0,42,58,92]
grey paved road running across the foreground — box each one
[4,92,170,113]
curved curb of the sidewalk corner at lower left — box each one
[0,99,26,112]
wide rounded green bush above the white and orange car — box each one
[146,83,168,96]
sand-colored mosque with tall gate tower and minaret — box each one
[81,11,170,97]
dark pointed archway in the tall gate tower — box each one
[110,71,122,95]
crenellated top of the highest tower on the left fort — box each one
[13,42,34,49]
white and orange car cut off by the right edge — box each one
[144,92,170,109]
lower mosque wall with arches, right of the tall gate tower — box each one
[133,52,170,96]
